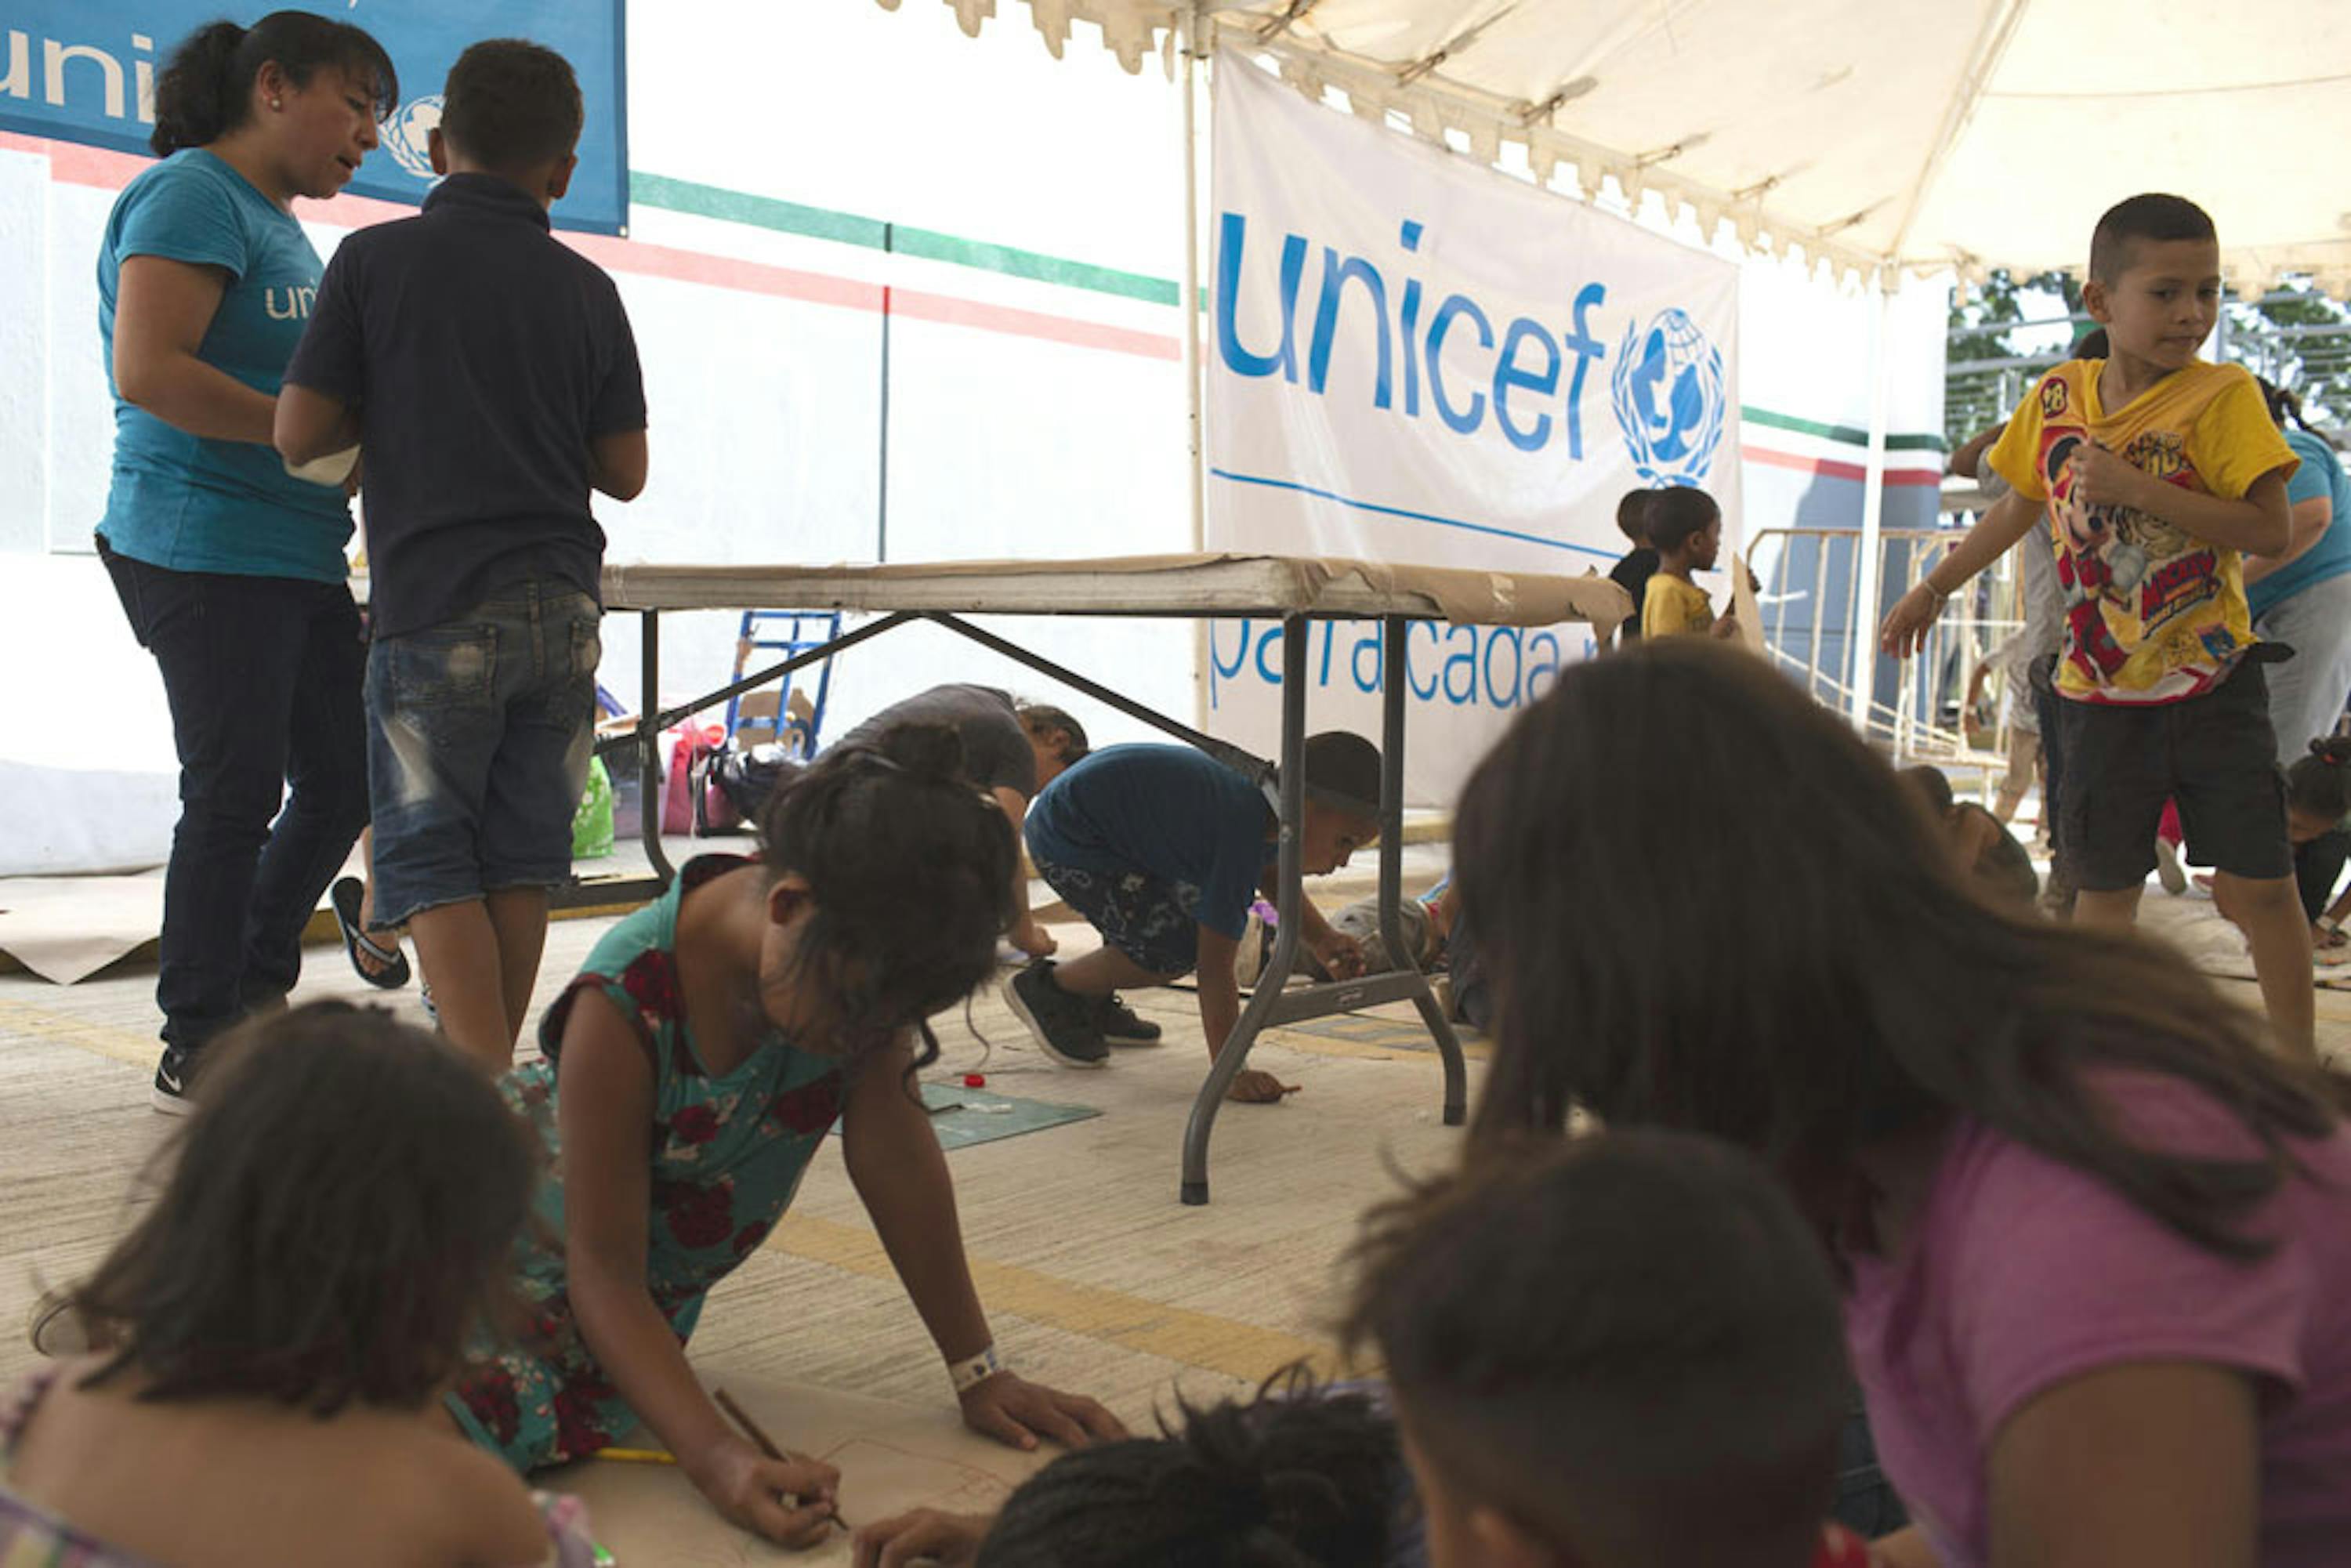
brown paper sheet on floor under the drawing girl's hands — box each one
[545,1380,1051,1568]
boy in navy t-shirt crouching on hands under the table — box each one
[1006,731,1380,1103]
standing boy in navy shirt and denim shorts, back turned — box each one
[277,40,647,1070]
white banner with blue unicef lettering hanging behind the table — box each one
[1206,54,1740,804]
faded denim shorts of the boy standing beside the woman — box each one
[367,581,602,926]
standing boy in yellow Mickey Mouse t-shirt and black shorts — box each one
[1881,195,2313,1056]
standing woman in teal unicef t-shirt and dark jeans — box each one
[99,12,400,1112]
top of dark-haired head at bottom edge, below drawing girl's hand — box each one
[978,1368,1404,1568]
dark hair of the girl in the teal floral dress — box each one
[759,724,1016,1065]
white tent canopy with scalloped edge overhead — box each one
[882,0,2351,296]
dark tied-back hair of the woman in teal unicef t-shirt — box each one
[148,12,400,158]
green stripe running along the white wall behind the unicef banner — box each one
[628,172,1947,451]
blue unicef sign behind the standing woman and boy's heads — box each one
[0,0,628,235]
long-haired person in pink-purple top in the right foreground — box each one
[1458,639,2351,1568]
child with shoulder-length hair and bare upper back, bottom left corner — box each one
[0,1001,592,1568]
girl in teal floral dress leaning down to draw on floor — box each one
[449,726,1124,1544]
